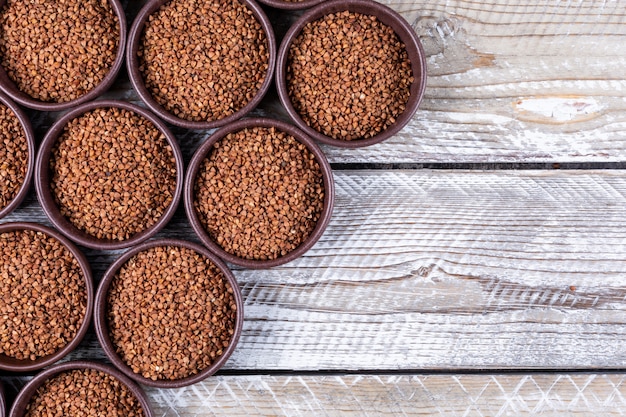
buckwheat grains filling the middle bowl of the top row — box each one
[138,0,269,121]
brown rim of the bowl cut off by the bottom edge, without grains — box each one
[9,361,153,417]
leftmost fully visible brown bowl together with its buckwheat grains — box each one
[35,100,184,250]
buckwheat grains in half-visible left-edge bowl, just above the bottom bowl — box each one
[0,230,87,360]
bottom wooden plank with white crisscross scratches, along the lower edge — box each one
[6,374,626,417]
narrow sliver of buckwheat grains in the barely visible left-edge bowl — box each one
[0,104,28,210]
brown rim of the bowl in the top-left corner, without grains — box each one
[0,0,127,111]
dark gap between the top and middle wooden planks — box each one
[330,161,626,171]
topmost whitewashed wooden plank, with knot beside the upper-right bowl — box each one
[32,0,626,163]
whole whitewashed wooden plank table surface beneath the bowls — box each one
[3,0,626,417]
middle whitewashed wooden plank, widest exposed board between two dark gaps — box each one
[5,170,626,372]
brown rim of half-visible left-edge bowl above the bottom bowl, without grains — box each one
[0,222,94,372]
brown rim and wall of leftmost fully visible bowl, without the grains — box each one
[35,100,184,250]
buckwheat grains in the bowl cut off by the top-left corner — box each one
[0,0,120,103]
